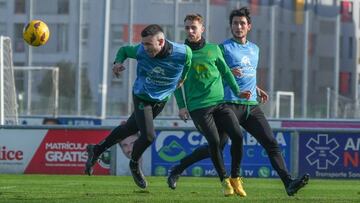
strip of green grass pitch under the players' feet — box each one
[0,175,360,203]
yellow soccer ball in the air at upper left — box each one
[23,20,50,47]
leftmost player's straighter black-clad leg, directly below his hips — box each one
[129,96,165,188]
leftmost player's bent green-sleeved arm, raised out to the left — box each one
[112,44,140,77]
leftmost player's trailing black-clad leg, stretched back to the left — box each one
[85,114,138,175]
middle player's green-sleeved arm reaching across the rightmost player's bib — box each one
[216,47,251,99]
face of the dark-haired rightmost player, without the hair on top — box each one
[231,16,251,39]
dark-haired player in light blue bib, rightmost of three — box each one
[168,7,309,196]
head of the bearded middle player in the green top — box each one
[184,13,205,42]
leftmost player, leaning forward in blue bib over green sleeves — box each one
[85,24,192,188]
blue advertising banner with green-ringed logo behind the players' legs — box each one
[152,130,291,177]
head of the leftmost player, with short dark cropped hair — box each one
[141,24,165,57]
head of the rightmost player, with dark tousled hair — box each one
[229,7,251,39]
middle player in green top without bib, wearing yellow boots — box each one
[175,14,250,196]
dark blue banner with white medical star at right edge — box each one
[299,133,360,178]
